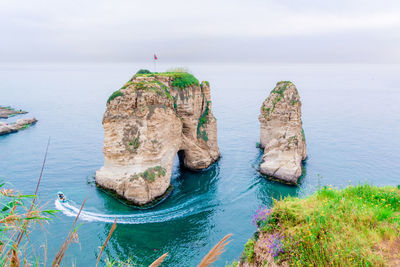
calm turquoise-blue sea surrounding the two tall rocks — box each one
[0,64,400,266]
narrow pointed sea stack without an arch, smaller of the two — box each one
[259,81,307,184]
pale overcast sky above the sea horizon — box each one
[0,0,400,63]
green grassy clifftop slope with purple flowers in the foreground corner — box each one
[244,185,400,266]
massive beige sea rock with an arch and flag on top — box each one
[96,73,220,205]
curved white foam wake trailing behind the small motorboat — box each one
[55,198,216,224]
